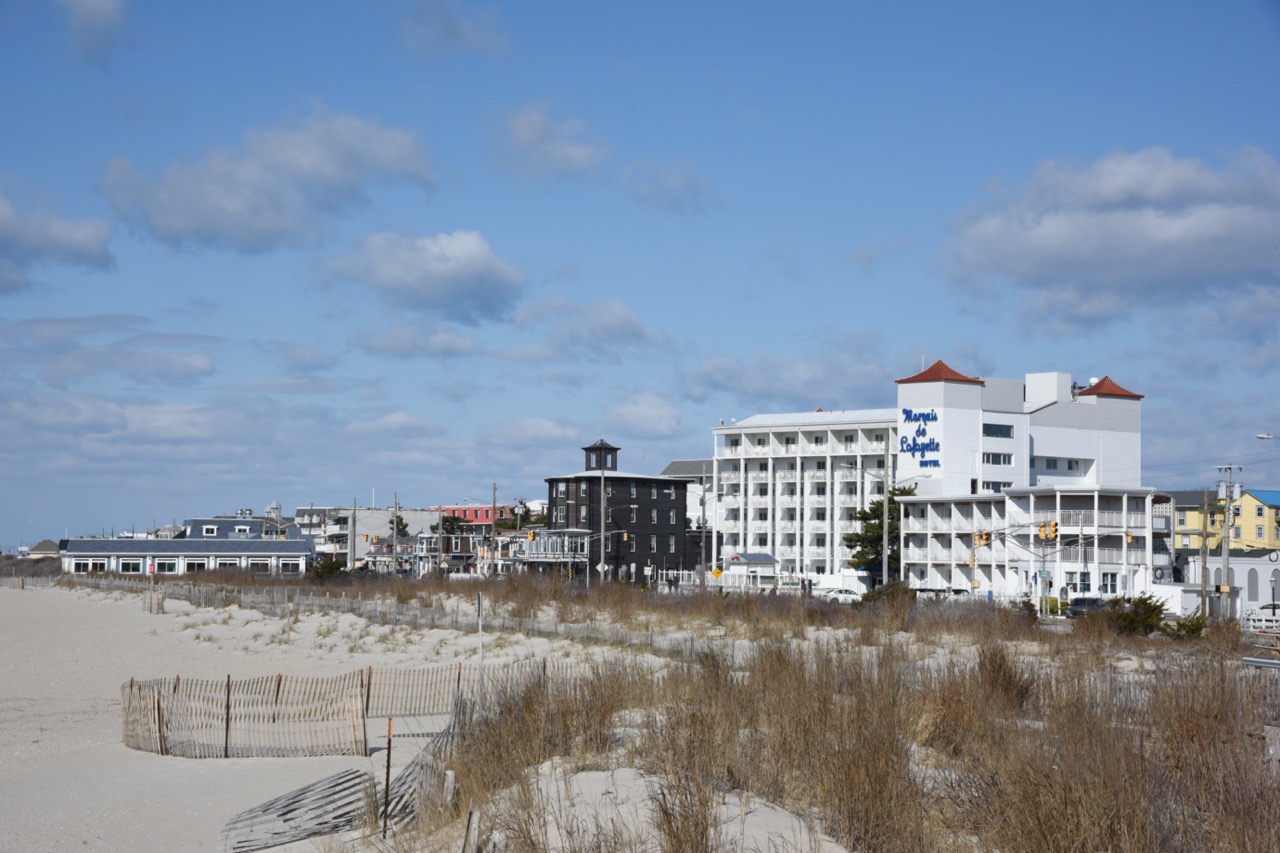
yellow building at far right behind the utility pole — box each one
[1170,489,1280,551]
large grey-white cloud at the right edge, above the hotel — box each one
[950,147,1280,332]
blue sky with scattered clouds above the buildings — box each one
[0,0,1280,552]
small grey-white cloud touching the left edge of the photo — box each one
[0,196,113,293]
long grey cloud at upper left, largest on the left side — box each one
[105,108,433,251]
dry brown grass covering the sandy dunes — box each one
[70,568,1280,853]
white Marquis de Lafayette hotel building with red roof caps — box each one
[712,361,1172,598]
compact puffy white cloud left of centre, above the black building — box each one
[330,231,525,324]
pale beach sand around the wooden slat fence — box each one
[0,589,842,853]
